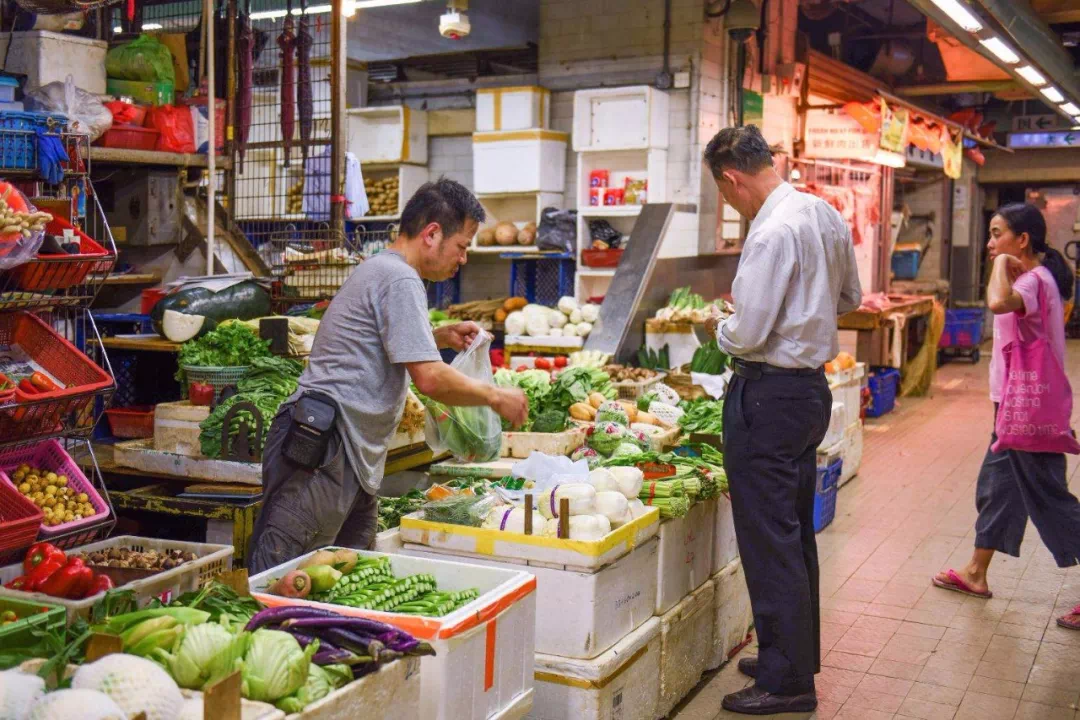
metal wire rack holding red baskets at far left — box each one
[0,128,117,548]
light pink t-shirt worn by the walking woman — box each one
[990,266,1065,403]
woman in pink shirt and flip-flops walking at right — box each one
[933,203,1080,629]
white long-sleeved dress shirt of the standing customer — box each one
[716,182,862,368]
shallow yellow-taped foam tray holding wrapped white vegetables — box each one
[401,505,660,572]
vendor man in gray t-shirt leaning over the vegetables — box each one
[248,179,528,573]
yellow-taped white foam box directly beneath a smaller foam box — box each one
[473,130,569,194]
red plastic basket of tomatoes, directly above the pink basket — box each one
[0,312,112,438]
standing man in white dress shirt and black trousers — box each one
[705,125,862,715]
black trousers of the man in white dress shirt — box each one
[724,375,833,695]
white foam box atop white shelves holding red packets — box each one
[573,85,670,152]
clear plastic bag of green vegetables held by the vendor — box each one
[424,332,502,462]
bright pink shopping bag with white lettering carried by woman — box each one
[991,279,1080,454]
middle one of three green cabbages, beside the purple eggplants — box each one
[241,629,319,703]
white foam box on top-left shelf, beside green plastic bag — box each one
[0,30,109,95]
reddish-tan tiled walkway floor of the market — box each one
[672,341,1080,720]
